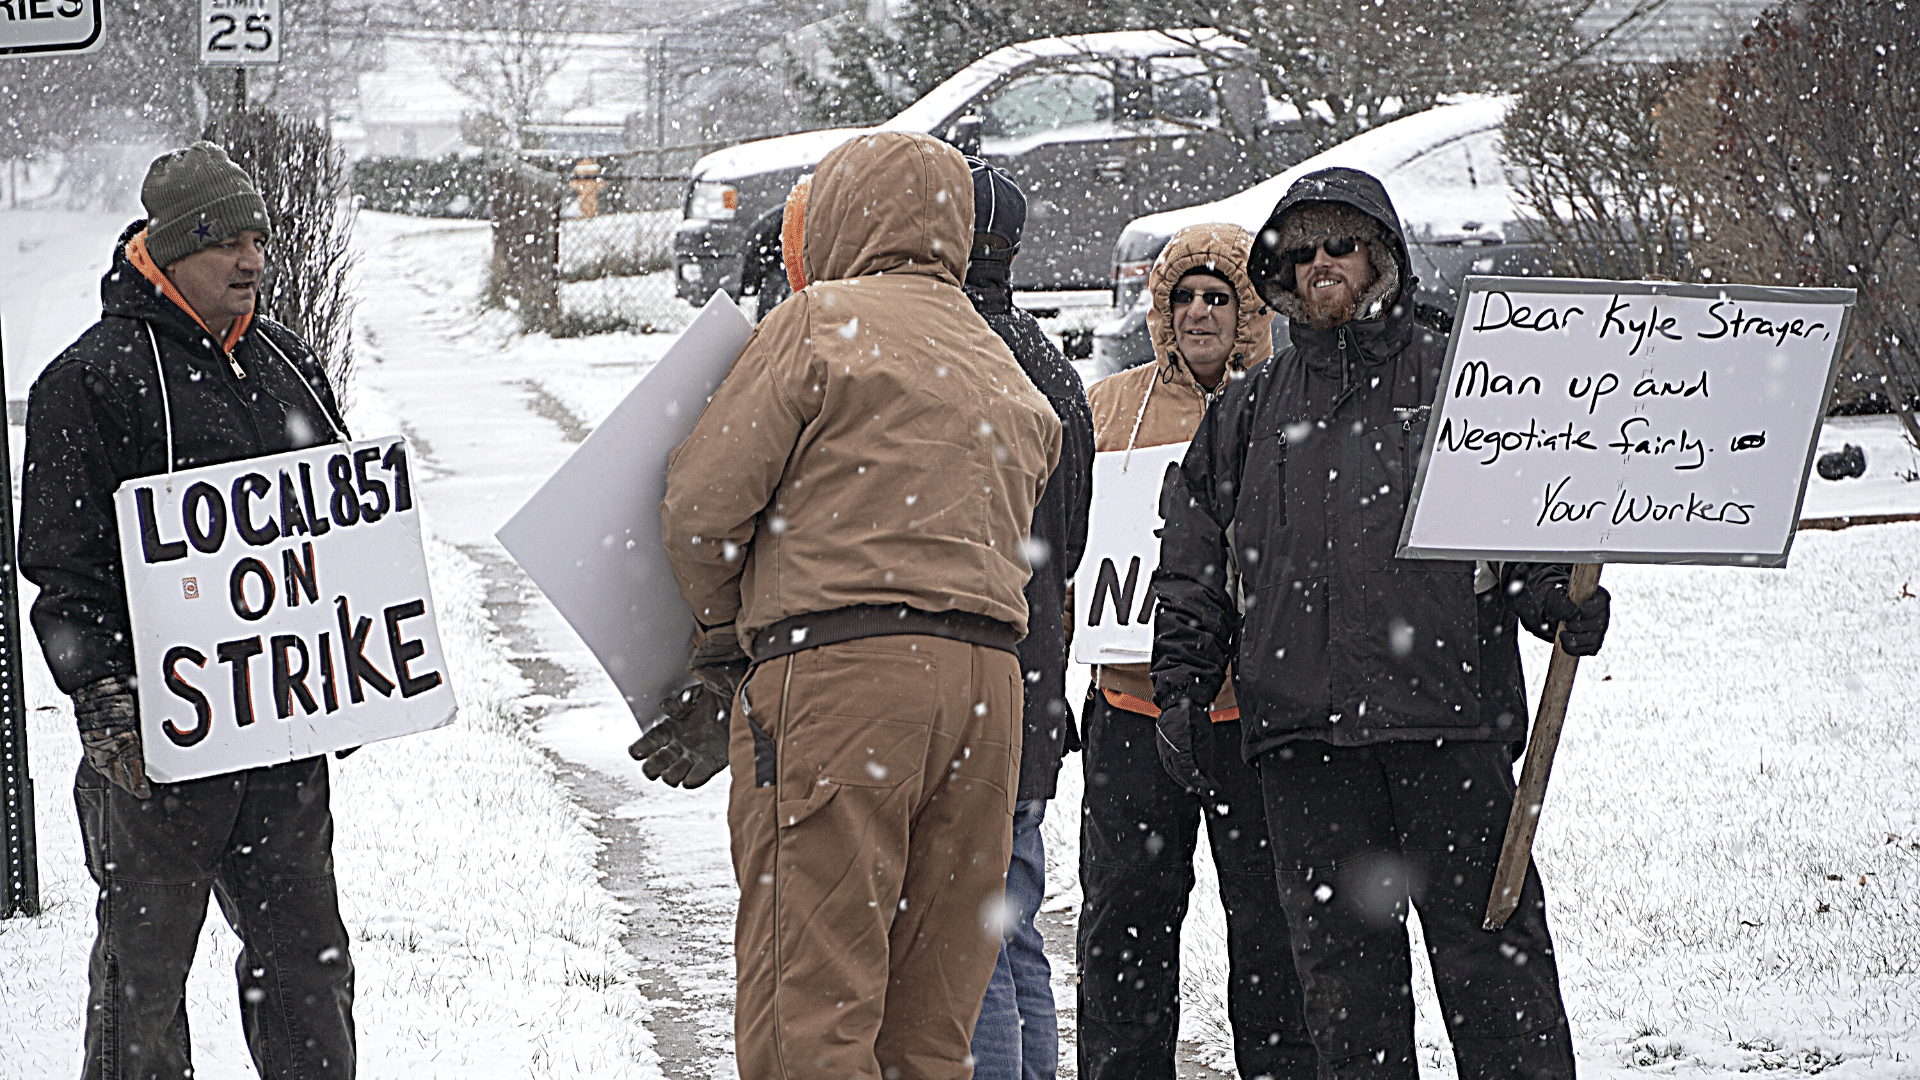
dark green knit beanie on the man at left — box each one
[140,142,271,269]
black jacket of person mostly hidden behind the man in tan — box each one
[966,259,1092,799]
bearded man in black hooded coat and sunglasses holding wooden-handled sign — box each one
[1152,169,1609,1080]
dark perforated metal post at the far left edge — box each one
[0,313,40,919]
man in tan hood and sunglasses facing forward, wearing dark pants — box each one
[1077,225,1317,1080]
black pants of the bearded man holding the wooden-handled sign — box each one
[1260,742,1572,1080]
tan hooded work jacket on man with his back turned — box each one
[660,133,1060,642]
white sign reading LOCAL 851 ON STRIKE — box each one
[113,438,457,782]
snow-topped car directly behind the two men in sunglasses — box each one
[1092,96,1548,377]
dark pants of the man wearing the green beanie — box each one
[73,757,353,1080]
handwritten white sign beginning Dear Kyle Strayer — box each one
[1400,277,1853,567]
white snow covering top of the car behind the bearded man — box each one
[1127,96,1513,236]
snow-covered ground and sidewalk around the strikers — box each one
[0,203,1920,1080]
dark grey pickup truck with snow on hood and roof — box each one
[674,31,1306,304]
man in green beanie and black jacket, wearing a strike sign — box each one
[19,142,355,1080]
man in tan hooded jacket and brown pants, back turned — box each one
[660,133,1060,1080]
